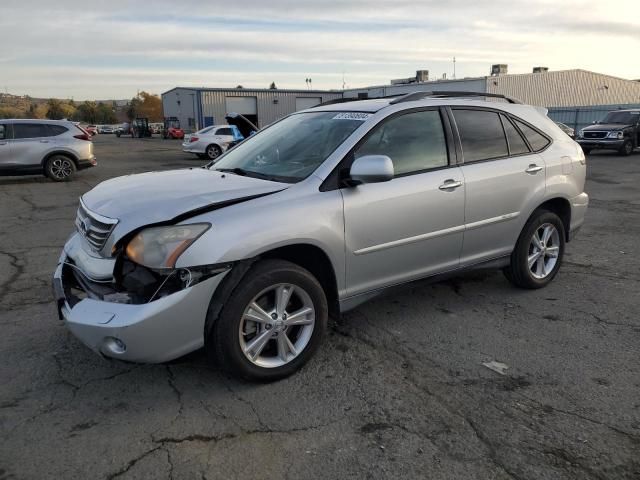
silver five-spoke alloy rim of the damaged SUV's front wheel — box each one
[239,283,316,368]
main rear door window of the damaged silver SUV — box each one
[453,109,509,162]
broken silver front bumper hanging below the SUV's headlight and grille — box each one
[53,235,229,363]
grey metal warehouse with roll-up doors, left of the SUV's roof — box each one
[162,87,342,131]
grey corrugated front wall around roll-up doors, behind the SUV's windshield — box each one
[200,89,342,128]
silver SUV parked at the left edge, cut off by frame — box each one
[0,120,96,182]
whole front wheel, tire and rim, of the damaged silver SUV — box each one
[206,260,328,382]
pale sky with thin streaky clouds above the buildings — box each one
[0,0,640,100]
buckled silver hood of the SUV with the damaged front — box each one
[82,168,290,244]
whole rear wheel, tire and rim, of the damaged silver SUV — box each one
[504,210,566,289]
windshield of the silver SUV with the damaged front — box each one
[210,112,370,183]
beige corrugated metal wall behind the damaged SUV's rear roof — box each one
[487,70,640,107]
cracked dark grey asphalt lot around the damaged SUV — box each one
[0,135,640,480]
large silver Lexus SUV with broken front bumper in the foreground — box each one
[54,93,588,381]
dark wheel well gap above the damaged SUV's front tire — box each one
[260,244,340,318]
